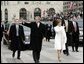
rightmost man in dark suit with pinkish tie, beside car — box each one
[72,17,79,52]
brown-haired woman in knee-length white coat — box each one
[54,18,67,61]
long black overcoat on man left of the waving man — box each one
[9,24,25,50]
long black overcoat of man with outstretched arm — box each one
[23,22,45,51]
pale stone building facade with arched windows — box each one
[1,1,63,21]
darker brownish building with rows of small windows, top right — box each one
[63,1,83,13]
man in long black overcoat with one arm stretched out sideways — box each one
[22,16,45,63]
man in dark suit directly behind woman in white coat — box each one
[62,17,73,56]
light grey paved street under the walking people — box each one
[1,39,83,63]
